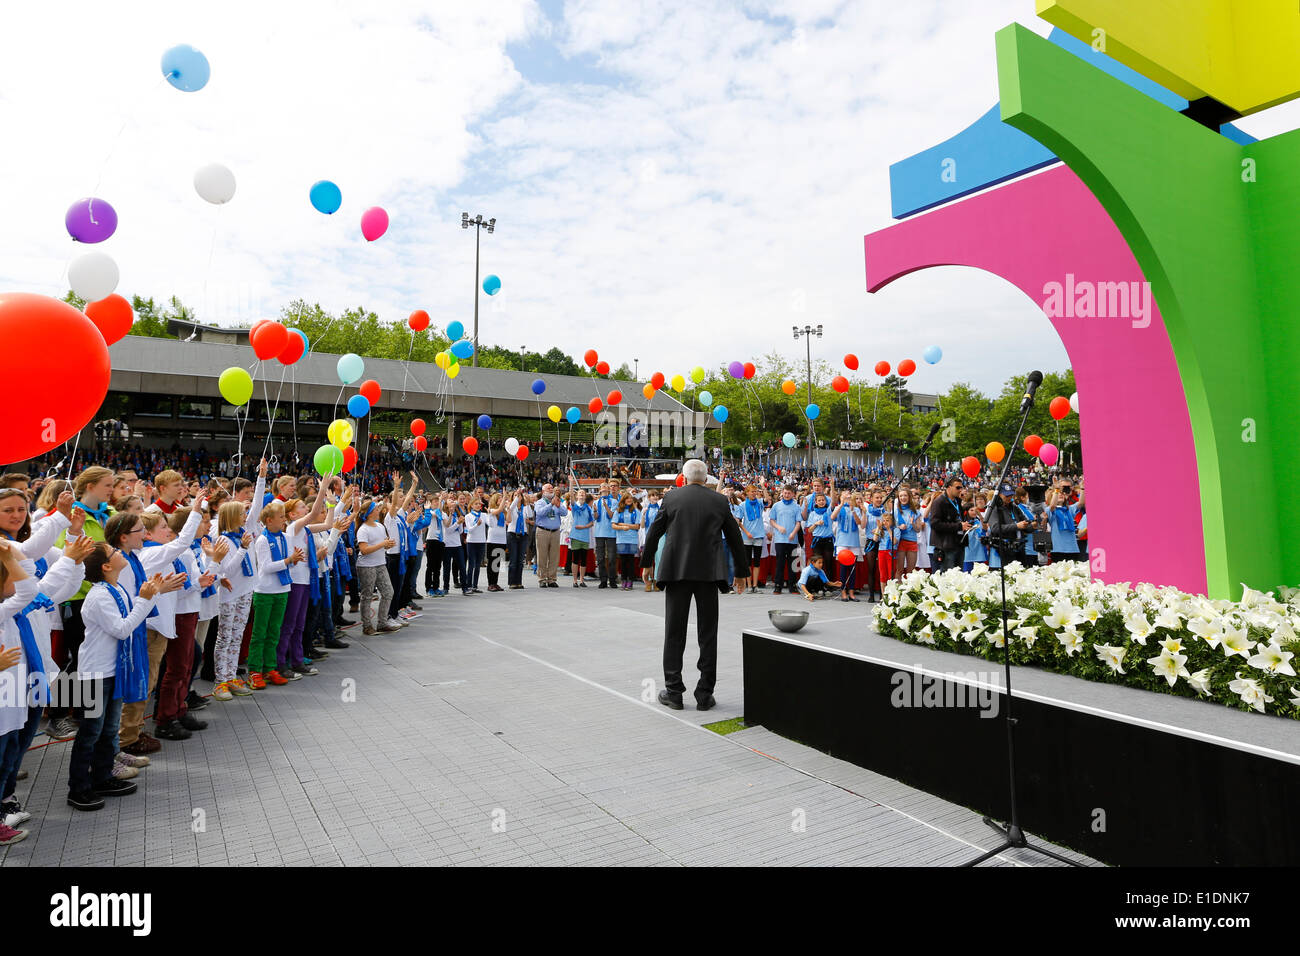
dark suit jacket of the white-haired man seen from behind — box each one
[641,485,749,583]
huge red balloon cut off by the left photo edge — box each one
[0,293,112,463]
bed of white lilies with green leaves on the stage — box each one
[875,562,1300,718]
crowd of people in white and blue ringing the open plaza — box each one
[0,455,1087,845]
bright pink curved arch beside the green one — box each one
[865,165,1206,594]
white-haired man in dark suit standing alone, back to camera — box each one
[641,458,749,710]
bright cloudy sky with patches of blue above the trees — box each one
[0,0,1291,392]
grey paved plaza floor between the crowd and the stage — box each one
[0,574,1097,866]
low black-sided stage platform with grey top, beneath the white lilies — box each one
[742,605,1300,866]
